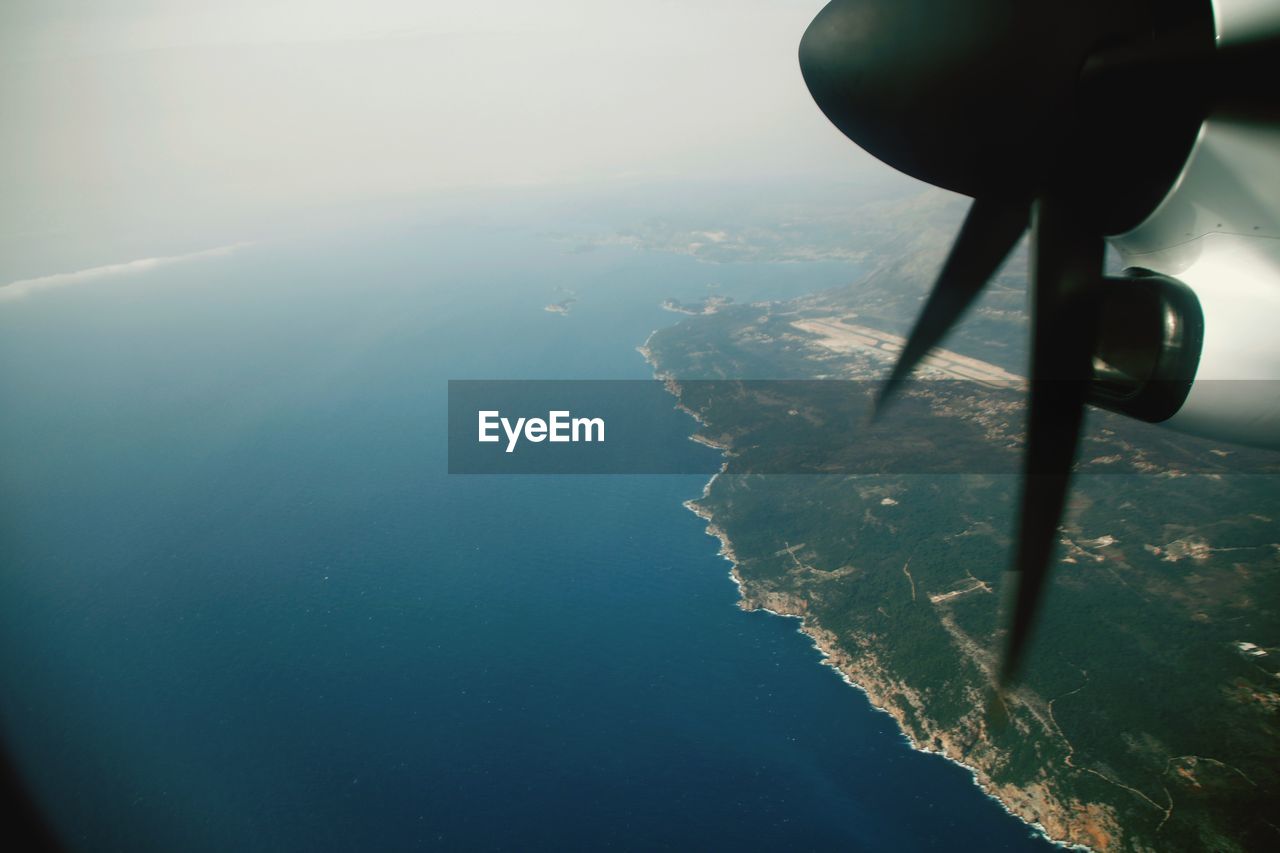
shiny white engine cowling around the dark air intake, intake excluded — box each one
[1096,0,1280,448]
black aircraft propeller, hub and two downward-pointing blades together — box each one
[800,0,1218,697]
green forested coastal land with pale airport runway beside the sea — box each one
[641,197,1280,850]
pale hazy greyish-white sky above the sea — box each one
[0,0,890,275]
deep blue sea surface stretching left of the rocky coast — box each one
[0,202,1047,850]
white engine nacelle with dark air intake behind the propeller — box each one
[1094,0,1280,450]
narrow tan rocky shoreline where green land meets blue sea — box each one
[636,329,1114,853]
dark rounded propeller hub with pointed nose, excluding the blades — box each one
[800,0,1213,233]
